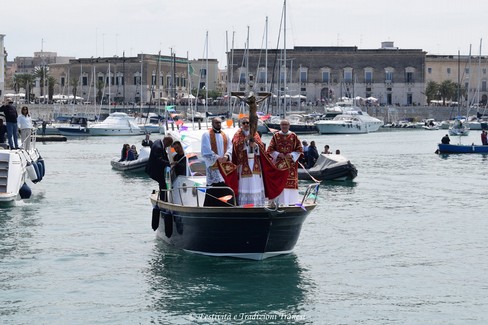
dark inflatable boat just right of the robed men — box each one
[298,153,358,181]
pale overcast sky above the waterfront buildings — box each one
[0,0,488,67]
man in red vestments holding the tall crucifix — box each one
[232,117,265,206]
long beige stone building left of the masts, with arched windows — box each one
[49,54,218,105]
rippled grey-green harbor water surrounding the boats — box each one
[0,130,488,325]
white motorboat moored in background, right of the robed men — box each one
[315,107,383,134]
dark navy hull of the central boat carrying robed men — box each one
[153,199,315,260]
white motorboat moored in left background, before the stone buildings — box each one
[88,112,144,136]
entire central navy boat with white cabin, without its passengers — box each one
[150,173,319,260]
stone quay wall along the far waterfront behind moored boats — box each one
[21,104,466,123]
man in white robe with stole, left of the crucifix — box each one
[201,117,235,206]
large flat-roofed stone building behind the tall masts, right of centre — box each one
[227,42,426,106]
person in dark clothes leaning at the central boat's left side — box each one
[145,136,173,200]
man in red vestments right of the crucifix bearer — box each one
[267,120,303,205]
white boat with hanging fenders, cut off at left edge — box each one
[0,134,45,202]
